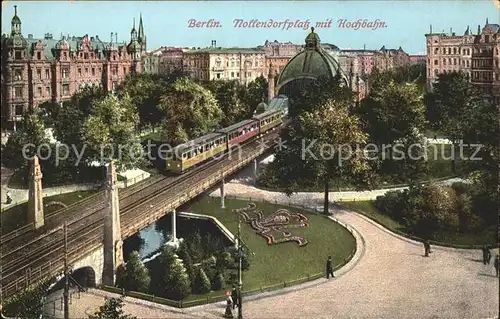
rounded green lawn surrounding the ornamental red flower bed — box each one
[183,196,356,300]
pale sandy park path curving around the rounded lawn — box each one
[52,183,499,319]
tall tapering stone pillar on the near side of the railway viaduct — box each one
[102,161,123,286]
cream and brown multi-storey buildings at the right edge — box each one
[425,19,500,103]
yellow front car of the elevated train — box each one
[166,133,227,174]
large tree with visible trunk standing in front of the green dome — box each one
[272,78,370,213]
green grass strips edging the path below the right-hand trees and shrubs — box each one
[340,201,497,245]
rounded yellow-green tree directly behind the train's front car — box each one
[159,77,222,144]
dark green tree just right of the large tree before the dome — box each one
[356,80,426,182]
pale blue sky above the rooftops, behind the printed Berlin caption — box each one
[2,0,500,54]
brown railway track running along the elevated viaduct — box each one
[2,132,278,298]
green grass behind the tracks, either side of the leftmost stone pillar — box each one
[1,190,98,234]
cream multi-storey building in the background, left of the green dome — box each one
[183,41,266,85]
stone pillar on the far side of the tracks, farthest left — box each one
[28,155,45,229]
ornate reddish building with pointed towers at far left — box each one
[1,6,146,129]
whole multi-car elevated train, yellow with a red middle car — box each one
[166,108,285,174]
